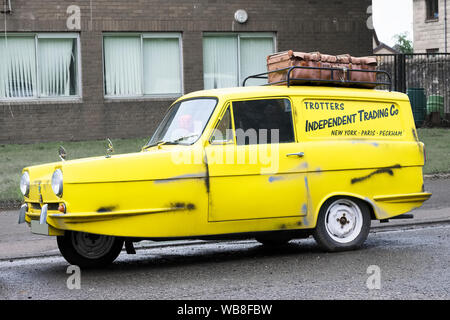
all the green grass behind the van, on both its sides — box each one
[0,129,450,202]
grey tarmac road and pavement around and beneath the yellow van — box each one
[0,179,450,300]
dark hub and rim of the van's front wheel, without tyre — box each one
[72,232,114,259]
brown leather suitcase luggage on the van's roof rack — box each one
[267,50,377,88]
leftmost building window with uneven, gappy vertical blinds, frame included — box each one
[0,34,78,99]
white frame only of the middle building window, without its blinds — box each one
[102,32,184,100]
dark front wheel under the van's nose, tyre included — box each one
[57,231,123,268]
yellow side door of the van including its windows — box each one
[205,98,307,221]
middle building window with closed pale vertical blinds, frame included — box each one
[104,33,182,97]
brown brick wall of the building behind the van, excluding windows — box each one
[0,0,372,143]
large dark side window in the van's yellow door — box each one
[233,99,295,145]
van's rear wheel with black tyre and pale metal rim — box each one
[313,197,371,252]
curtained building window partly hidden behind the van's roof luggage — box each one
[203,33,275,89]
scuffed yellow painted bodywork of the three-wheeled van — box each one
[24,86,431,238]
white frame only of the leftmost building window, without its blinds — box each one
[0,32,83,102]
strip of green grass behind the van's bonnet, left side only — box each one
[0,138,148,201]
